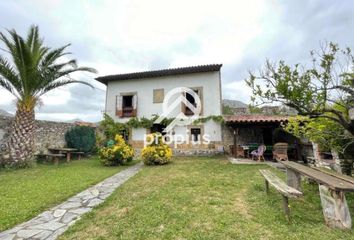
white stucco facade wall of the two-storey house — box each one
[106,72,221,141]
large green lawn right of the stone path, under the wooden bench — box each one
[61,158,354,240]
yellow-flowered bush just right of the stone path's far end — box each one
[141,133,172,165]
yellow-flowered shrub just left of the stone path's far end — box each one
[98,135,134,166]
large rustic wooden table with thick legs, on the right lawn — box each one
[281,161,354,229]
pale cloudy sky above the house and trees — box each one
[0,0,354,121]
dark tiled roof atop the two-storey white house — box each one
[96,64,222,85]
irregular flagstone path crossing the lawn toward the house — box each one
[0,163,143,240]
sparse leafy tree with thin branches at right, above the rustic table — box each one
[246,43,354,135]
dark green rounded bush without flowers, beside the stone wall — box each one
[65,126,96,153]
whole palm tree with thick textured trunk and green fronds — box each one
[0,26,96,167]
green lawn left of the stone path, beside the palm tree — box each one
[0,158,135,231]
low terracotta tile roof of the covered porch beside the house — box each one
[224,114,289,123]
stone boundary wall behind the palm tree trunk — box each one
[0,116,75,153]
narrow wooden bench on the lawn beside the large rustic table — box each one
[259,169,303,221]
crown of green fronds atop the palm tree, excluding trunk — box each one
[0,26,96,106]
